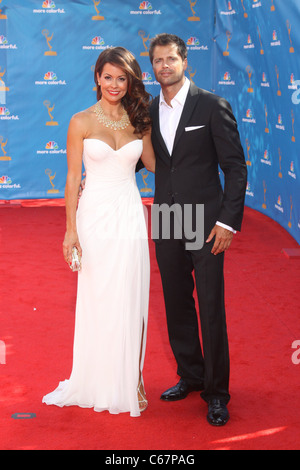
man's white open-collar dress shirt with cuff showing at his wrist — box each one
[159,77,236,237]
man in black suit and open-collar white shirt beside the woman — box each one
[149,34,247,426]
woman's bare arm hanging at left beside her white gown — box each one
[63,114,83,264]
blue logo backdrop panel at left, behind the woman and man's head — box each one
[0,0,213,200]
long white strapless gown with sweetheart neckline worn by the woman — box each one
[43,139,150,416]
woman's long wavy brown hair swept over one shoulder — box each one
[94,47,151,135]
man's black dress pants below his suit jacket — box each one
[155,239,230,403]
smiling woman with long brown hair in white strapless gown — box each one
[43,47,155,416]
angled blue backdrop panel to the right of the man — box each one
[213,0,300,242]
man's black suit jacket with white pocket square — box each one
[151,84,247,236]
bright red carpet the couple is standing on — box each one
[0,202,300,451]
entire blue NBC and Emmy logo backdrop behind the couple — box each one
[0,0,300,242]
